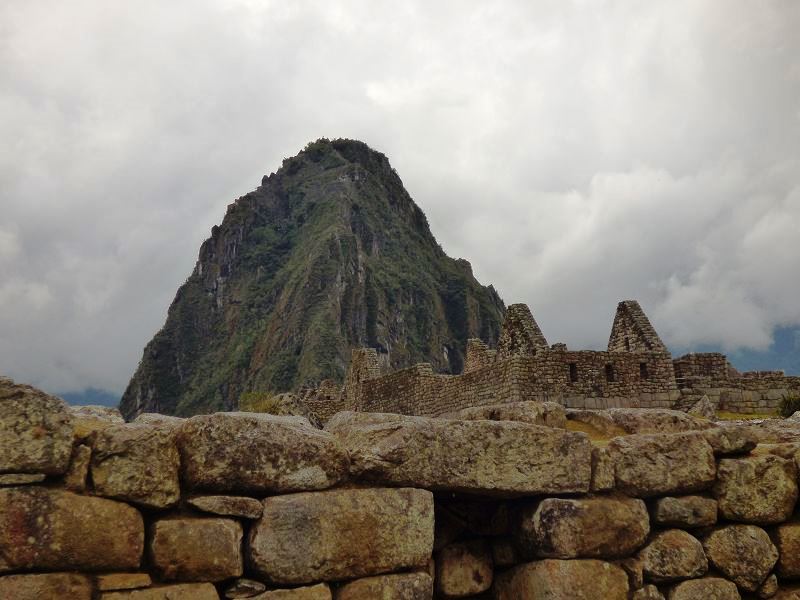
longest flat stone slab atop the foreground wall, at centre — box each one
[325,413,591,495]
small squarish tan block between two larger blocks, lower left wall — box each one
[149,517,242,581]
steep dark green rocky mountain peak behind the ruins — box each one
[120,139,505,417]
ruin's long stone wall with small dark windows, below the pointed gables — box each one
[360,349,679,416]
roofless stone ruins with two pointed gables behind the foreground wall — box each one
[302,300,800,421]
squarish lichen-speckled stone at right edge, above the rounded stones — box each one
[714,455,797,524]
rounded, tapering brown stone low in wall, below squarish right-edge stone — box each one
[703,525,778,592]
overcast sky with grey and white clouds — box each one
[0,0,800,394]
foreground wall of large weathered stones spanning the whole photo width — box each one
[0,379,800,600]
